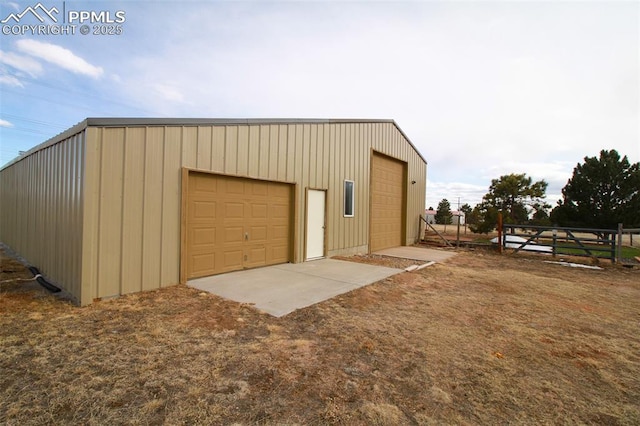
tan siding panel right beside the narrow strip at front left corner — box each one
[98,128,124,297]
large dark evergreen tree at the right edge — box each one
[551,149,640,229]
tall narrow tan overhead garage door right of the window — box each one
[370,153,405,252]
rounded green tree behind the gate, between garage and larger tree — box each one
[471,173,551,233]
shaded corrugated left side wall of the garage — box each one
[0,131,84,298]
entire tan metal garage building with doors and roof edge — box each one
[0,118,427,305]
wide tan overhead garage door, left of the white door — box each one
[186,172,292,278]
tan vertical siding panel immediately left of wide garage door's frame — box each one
[160,127,181,287]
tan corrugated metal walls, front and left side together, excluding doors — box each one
[0,122,426,305]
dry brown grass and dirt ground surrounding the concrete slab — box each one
[0,250,640,425]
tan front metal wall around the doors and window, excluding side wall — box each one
[82,123,426,304]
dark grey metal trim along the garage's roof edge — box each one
[5,117,427,171]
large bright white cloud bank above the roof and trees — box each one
[112,2,640,207]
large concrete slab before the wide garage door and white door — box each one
[187,259,403,317]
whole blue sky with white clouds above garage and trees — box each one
[0,0,640,207]
